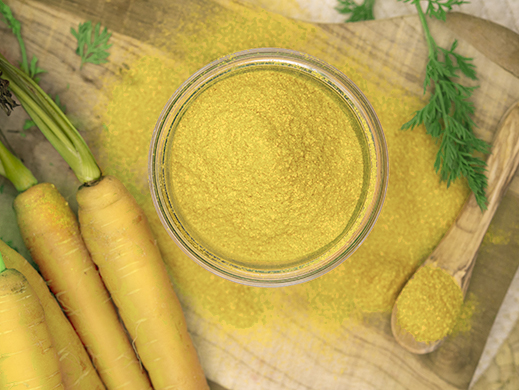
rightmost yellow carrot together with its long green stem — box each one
[0,55,208,390]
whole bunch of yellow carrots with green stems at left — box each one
[0,29,208,390]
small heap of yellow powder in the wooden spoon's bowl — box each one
[396,266,463,343]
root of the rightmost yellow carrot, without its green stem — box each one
[76,176,208,390]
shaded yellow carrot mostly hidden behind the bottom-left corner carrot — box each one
[0,240,105,390]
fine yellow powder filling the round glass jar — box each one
[165,69,374,266]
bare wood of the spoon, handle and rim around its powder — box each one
[391,102,519,354]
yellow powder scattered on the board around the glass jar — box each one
[98,4,469,333]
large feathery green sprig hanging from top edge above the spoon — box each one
[402,0,490,210]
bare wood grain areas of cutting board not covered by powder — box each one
[0,0,519,390]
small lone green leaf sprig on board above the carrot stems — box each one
[70,21,112,68]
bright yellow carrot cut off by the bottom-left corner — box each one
[0,256,65,390]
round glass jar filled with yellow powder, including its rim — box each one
[149,48,389,287]
